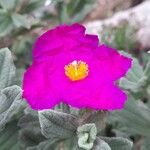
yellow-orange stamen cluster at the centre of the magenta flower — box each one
[64,60,89,81]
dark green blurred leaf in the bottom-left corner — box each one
[0,121,19,150]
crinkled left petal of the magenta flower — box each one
[23,63,60,110]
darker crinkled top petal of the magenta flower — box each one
[33,23,98,60]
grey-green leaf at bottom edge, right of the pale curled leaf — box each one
[100,137,133,150]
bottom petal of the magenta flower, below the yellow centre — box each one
[64,80,127,110]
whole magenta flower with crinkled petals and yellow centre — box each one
[23,23,132,110]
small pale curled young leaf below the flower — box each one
[77,123,97,150]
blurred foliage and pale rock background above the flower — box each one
[0,0,150,82]
